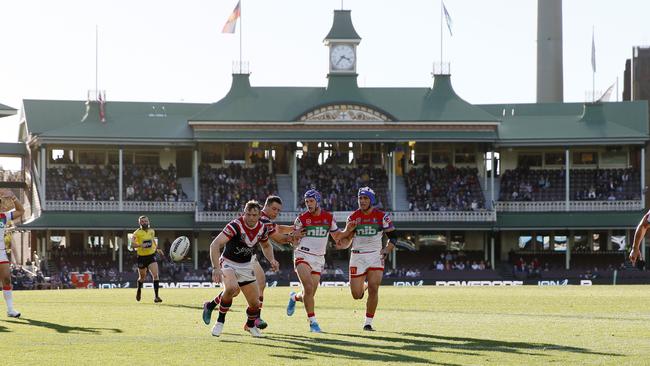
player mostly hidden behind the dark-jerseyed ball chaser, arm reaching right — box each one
[203,196,302,330]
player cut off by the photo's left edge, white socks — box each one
[0,189,25,318]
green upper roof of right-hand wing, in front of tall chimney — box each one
[480,101,649,146]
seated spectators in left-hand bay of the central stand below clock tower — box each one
[199,164,278,211]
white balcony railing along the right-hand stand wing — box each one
[496,201,644,212]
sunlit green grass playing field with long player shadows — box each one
[0,286,650,366]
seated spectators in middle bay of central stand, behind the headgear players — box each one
[297,155,389,211]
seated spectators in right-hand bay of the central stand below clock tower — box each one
[404,165,485,211]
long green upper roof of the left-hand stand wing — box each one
[23,100,207,144]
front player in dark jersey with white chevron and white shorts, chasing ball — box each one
[200,201,279,337]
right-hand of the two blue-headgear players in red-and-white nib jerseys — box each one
[337,187,396,331]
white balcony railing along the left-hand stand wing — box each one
[43,201,196,212]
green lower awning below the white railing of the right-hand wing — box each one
[496,211,643,230]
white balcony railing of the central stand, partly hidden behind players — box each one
[195,211,497,223]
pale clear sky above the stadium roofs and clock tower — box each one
[0,0,650,169]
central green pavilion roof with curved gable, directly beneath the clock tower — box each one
[190,74,499,123]
